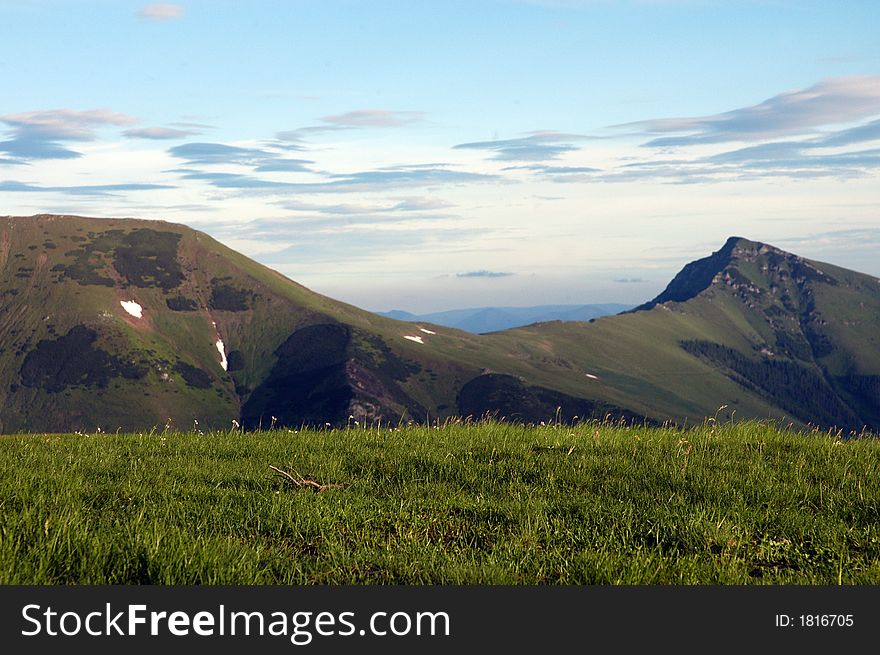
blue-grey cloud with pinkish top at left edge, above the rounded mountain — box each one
[0,109,137,160]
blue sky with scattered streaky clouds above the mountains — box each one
[0,0,880,312]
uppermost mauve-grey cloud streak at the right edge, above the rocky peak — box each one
[615,75,880,148]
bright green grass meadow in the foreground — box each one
[0,419,880,584]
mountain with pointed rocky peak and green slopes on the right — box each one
[498,237,880,432]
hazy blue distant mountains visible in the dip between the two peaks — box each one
[379,303,633,334]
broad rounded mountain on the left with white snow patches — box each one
[0,215,624,433]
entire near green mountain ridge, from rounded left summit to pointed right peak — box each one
[0,215,880,433]
